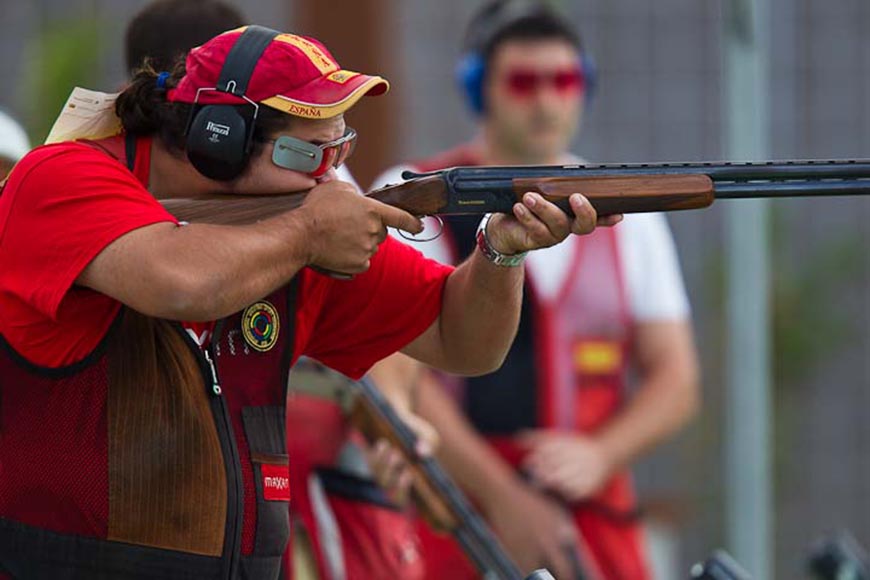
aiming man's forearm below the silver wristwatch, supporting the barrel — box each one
[434,250,523,375]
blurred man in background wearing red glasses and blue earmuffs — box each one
[375,0,699,580]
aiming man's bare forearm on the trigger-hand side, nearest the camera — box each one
[77,212,306,321]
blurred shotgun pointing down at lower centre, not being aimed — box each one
[290,359,552,580]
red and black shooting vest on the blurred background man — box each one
[416,146,649,580]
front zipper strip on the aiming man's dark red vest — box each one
[181,320,243,580]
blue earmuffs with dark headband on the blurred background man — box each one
[456,0,597,115]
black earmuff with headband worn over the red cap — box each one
[185,26,280,181]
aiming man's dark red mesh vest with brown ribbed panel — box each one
[0,138,296,580]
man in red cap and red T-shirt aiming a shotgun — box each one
[0,26,618,579]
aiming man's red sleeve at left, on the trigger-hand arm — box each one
[0,143,176,366]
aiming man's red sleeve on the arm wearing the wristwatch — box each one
[304,236,453,378]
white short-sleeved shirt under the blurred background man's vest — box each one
[372,165,691,322]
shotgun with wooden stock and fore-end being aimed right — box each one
[163,160,870,224]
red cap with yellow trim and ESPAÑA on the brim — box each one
[167,27,390,119]
